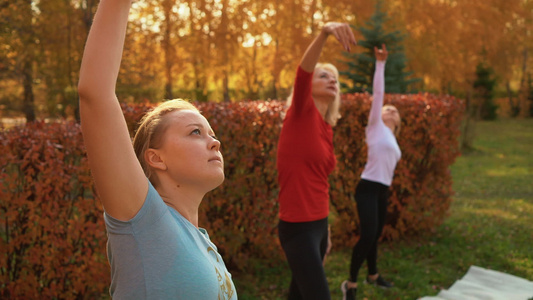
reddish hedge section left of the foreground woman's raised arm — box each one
[0,122,109,299]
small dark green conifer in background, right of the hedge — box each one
[474,63,498,120]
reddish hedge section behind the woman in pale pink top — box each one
[330,94,464,246]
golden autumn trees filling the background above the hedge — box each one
[0,0,533,120]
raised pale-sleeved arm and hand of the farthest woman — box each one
[368,44,388,125]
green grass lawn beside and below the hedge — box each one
[234,119,533,299]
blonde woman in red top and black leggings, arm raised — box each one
[277,23,356,299]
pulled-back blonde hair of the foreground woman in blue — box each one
[133,99,200,184]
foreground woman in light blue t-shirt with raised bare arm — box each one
[78,0,237,300]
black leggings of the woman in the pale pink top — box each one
[350,179,389,282]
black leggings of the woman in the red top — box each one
[278,218,331,300]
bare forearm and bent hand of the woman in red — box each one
[300,22,356,73]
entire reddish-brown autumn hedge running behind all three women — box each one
[0,94,463,298]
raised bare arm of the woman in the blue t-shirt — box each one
[78,0,148,220]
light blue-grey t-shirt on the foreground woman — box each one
[104,179,237,300]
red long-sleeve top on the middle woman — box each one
[277,67,336,222]
